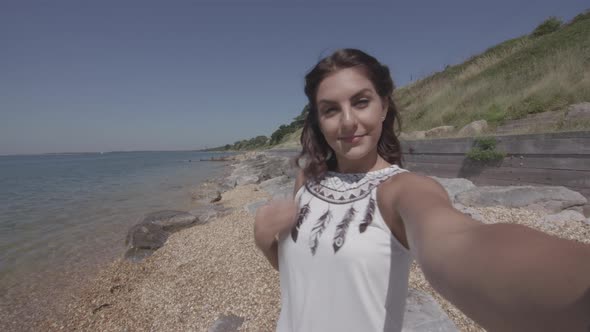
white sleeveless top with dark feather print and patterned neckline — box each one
[277,165,413,332]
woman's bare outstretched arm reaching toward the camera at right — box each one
[394,174,590,332]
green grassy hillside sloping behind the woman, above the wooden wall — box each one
[210,11,590,150]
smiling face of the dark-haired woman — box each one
[316,68,387,165]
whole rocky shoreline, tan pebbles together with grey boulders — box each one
[38,153,590,332]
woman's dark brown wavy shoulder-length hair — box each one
[296,48,402,179]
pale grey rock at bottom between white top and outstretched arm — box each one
[402,288,459,332]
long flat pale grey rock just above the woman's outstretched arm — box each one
[455,186,587,213]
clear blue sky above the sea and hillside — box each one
[0,0,590,154]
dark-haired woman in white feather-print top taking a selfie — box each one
[255,49,590,332]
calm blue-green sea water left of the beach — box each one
[0,151,230,301]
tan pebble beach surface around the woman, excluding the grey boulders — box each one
[28,167,590,331]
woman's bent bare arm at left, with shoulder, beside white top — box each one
[254,172,305,271]
